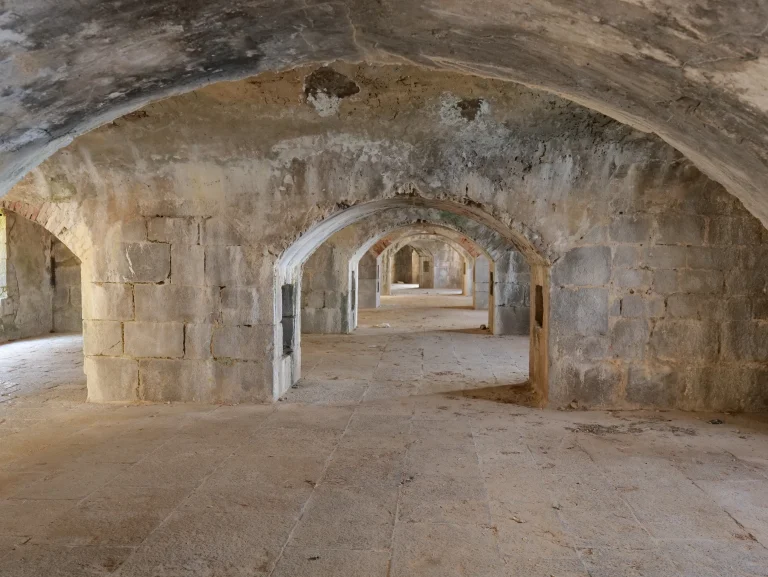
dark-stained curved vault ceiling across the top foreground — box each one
[0,0,768,223]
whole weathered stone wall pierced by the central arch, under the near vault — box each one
[6,63,768,410]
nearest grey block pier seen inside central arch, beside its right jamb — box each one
[492,251,531,335]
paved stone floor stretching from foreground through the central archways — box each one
[0,294,768,577]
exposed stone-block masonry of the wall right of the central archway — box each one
[550,200,768,411]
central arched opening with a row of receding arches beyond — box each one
[294,219,530,403]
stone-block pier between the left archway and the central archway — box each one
[82,217,275,403]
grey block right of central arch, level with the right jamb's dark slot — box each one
[550,287,608,335]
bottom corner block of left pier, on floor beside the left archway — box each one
[85,357,139,403]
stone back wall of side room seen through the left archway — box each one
[0,211,82,342]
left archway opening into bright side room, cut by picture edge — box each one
[0,205,85,406]
